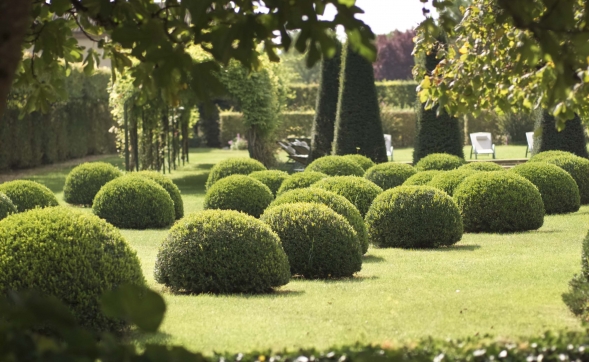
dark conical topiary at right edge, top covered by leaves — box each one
[533,110,589,158]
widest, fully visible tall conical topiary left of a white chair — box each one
[333,46,387,163]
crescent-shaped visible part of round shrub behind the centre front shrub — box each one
[268,188,368,254]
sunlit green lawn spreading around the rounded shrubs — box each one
[0,146,589,354]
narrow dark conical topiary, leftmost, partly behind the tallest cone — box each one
[310,43,342,160]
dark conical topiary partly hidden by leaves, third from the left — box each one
[413,37,464,164]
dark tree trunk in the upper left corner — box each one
[0,0,32,116]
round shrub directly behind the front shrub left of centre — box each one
[204,175,274,217]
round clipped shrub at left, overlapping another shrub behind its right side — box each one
[92,174,176,229]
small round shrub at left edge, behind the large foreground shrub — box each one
[0,180,59,212]
